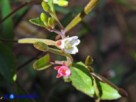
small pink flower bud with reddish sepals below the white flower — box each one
[54,64,71,78]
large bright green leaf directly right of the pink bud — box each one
[70,62,94,97]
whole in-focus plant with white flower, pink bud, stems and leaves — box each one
[18,0,126,102]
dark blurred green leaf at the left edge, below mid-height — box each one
[0,44,16,83]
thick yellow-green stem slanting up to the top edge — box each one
[65,0,99,32]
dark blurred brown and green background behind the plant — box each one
[0,0,136,102]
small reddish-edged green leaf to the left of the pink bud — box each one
[33,54,51,70]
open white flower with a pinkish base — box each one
[58,36,80,54]
